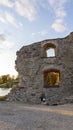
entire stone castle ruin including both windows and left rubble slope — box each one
[8,33,73,105]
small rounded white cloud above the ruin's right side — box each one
[52,19,66,32]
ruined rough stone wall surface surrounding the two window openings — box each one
[7,33,73,103]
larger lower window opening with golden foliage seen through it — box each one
[44,69,60,88]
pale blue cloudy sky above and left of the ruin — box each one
[0,0,73,75]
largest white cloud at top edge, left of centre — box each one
[15,0,36,21]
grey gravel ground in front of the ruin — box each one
[0,102,73,130]
